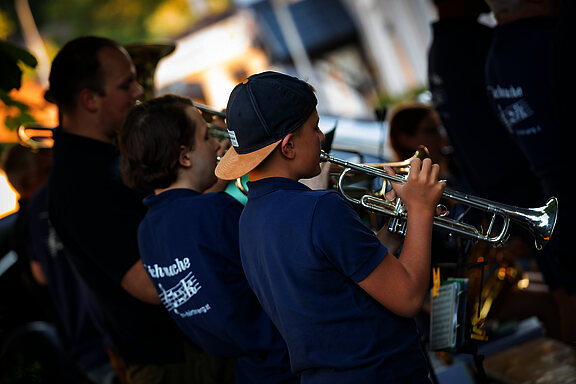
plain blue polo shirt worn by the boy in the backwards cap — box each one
[240,178,428,384]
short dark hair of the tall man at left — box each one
[45,36,123,109]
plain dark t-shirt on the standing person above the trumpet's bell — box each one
[428,18,542,207]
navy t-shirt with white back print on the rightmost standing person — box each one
[486,18,569,182]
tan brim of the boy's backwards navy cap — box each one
[215,139,282,180]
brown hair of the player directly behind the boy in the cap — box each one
[118,94,197,191]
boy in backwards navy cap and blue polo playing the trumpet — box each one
[216,72,444,384]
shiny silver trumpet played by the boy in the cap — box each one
[320,151,558,250]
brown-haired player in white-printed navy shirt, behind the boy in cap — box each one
[119,95,297,384]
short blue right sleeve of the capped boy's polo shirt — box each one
[312,193,388,282]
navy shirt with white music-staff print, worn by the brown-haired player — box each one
[138,189,297,384]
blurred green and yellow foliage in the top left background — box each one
[0,0,233,134]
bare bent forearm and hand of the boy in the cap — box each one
[358,159,445,317]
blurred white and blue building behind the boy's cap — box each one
[156,0,435,118]
